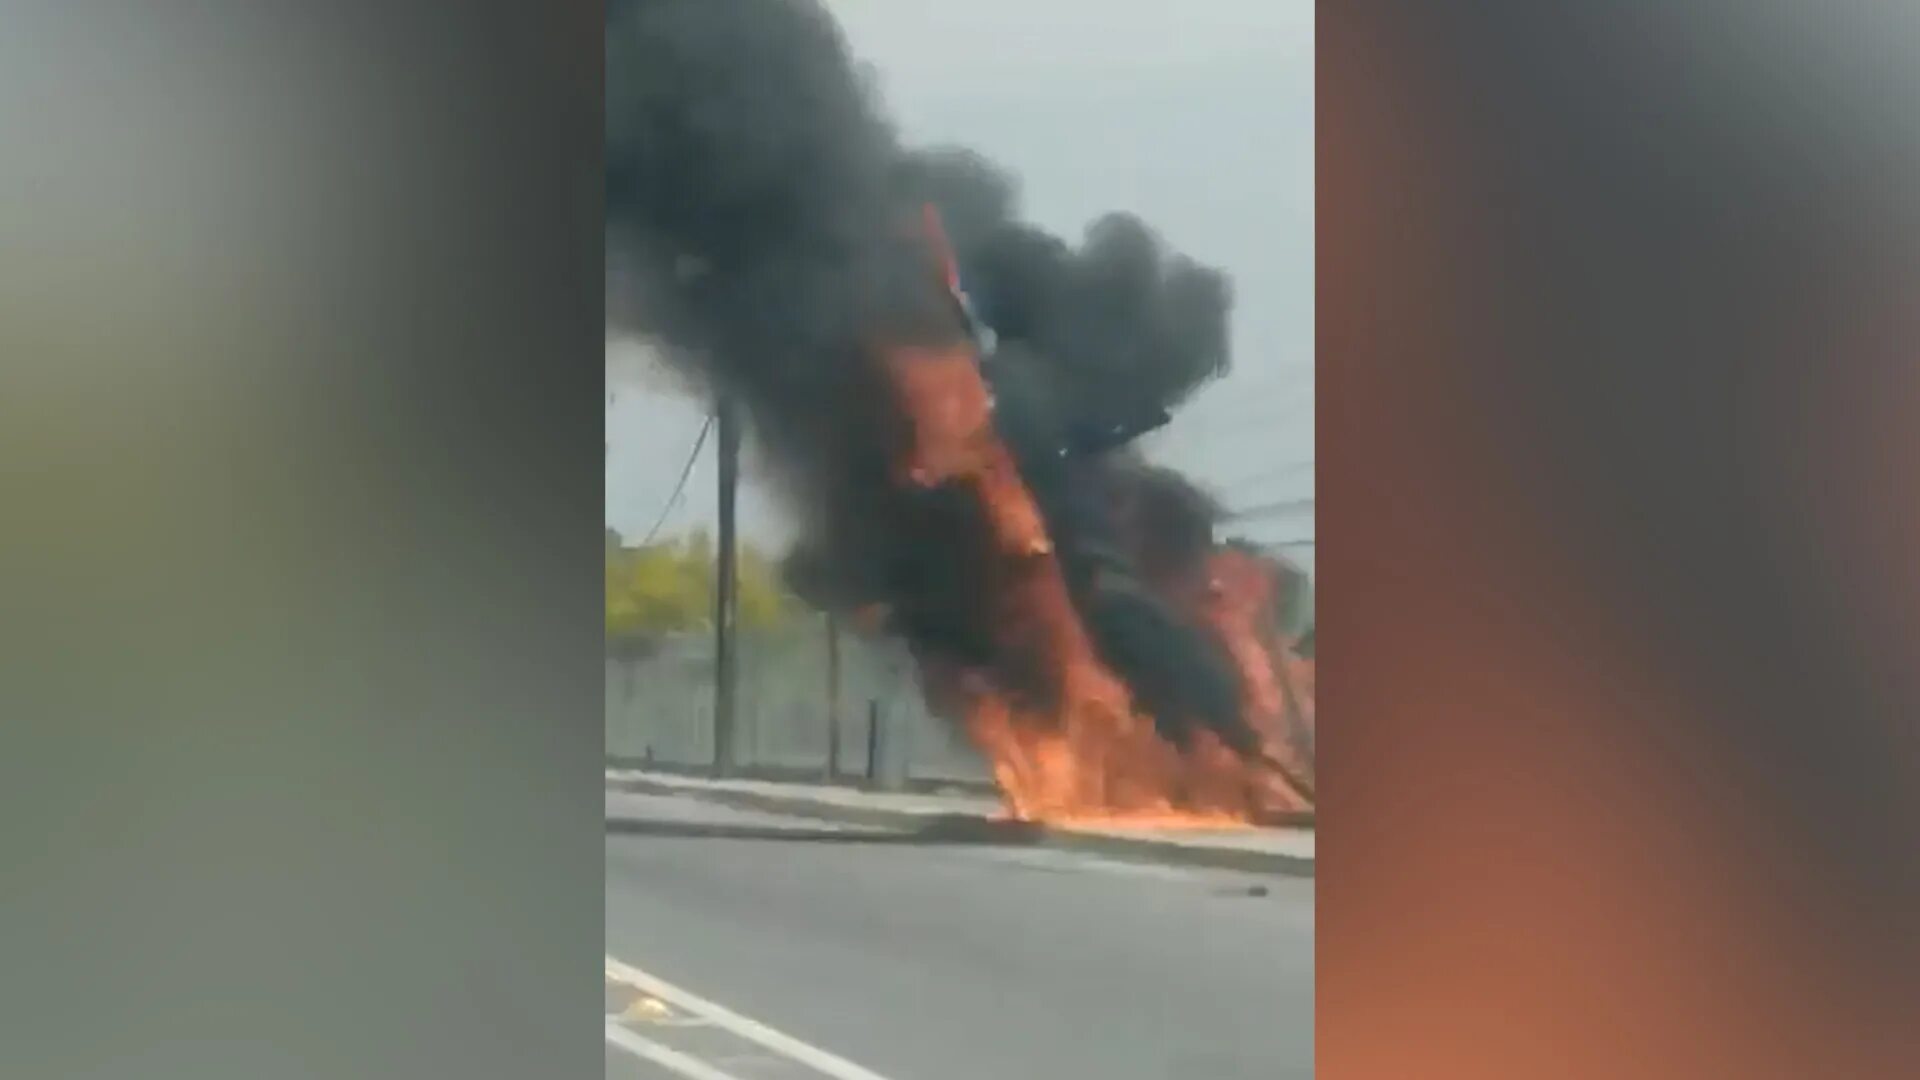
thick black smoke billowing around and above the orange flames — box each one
[607,0,1254,751]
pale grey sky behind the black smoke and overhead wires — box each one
[607,0,1313,565]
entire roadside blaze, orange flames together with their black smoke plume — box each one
[607,0,1313,826]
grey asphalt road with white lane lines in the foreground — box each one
[607,794,1313,1080]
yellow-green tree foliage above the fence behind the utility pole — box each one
[607,530,797,642]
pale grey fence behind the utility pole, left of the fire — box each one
[607,619,989,784]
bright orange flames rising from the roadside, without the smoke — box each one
[883,344,1311,828]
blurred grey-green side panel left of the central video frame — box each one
[0,8,605,1080]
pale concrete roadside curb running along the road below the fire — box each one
[607,774,1313,878]
